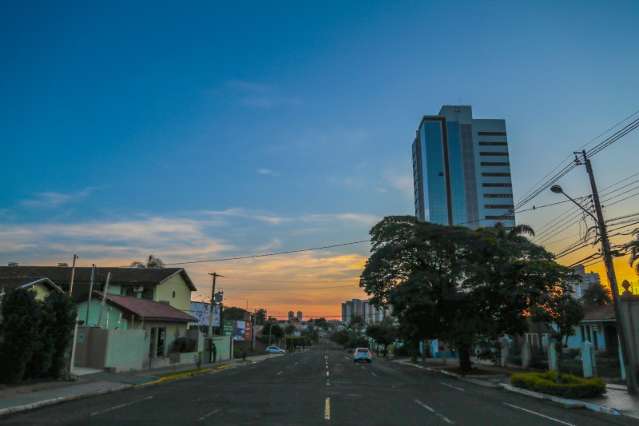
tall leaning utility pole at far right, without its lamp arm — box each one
[575,150,637,394]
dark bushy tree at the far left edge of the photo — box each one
[0,289,41,383]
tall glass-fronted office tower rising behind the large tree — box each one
[413,105,515,228]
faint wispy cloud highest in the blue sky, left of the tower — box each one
[227,80,302,109]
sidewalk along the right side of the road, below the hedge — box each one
[395,358,639,419]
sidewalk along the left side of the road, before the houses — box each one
[0,354,280,416]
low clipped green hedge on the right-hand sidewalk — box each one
[510,371,606,398]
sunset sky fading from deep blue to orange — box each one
[0,0,639,317]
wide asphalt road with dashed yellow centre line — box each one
[0,346,639,426]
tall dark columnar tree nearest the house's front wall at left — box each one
[44,292,77,378]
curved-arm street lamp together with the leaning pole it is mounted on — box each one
[550,183,637,394]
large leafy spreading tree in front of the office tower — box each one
[360,216,569,371]
